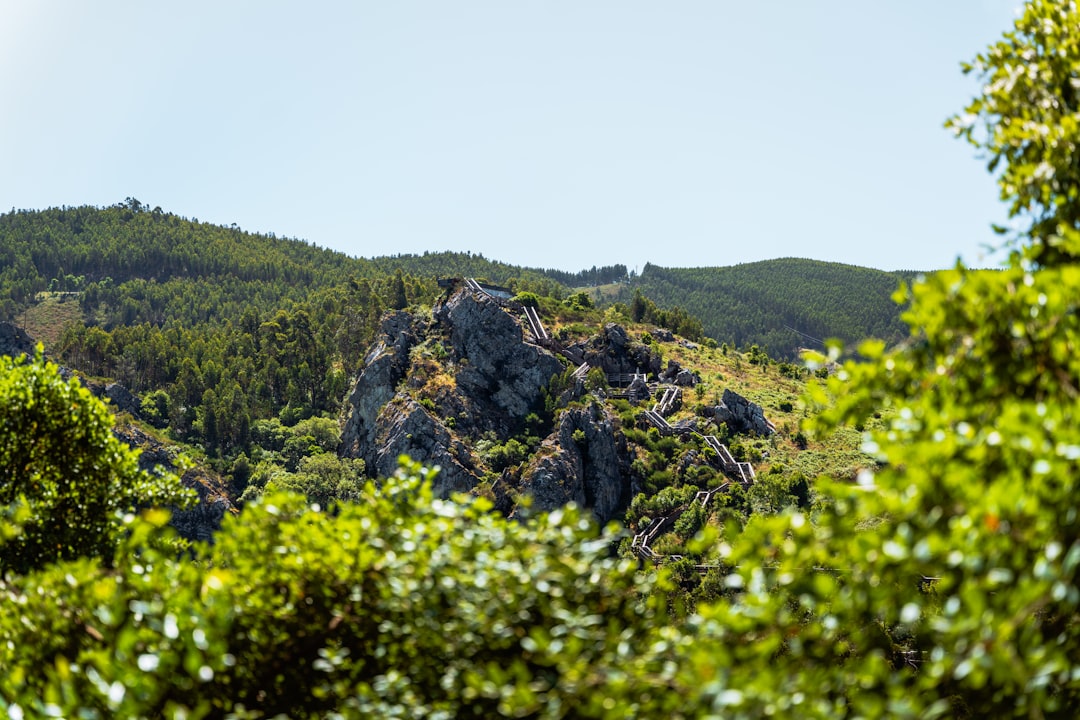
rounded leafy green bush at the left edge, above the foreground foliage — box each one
[0,345,193,573]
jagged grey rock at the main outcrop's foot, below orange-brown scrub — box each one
[365,394,481,498]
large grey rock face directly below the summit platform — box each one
[434,291,563,437]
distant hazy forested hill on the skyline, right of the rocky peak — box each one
[623,258,918,358]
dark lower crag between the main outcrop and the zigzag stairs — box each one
[522,403,633,522]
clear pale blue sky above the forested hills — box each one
[0,0,1020,270]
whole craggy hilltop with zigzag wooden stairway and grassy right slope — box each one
[328,281,874,587]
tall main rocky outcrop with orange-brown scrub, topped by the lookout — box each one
[340,289,563,497]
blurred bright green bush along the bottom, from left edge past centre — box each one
[0,466,699,718]
